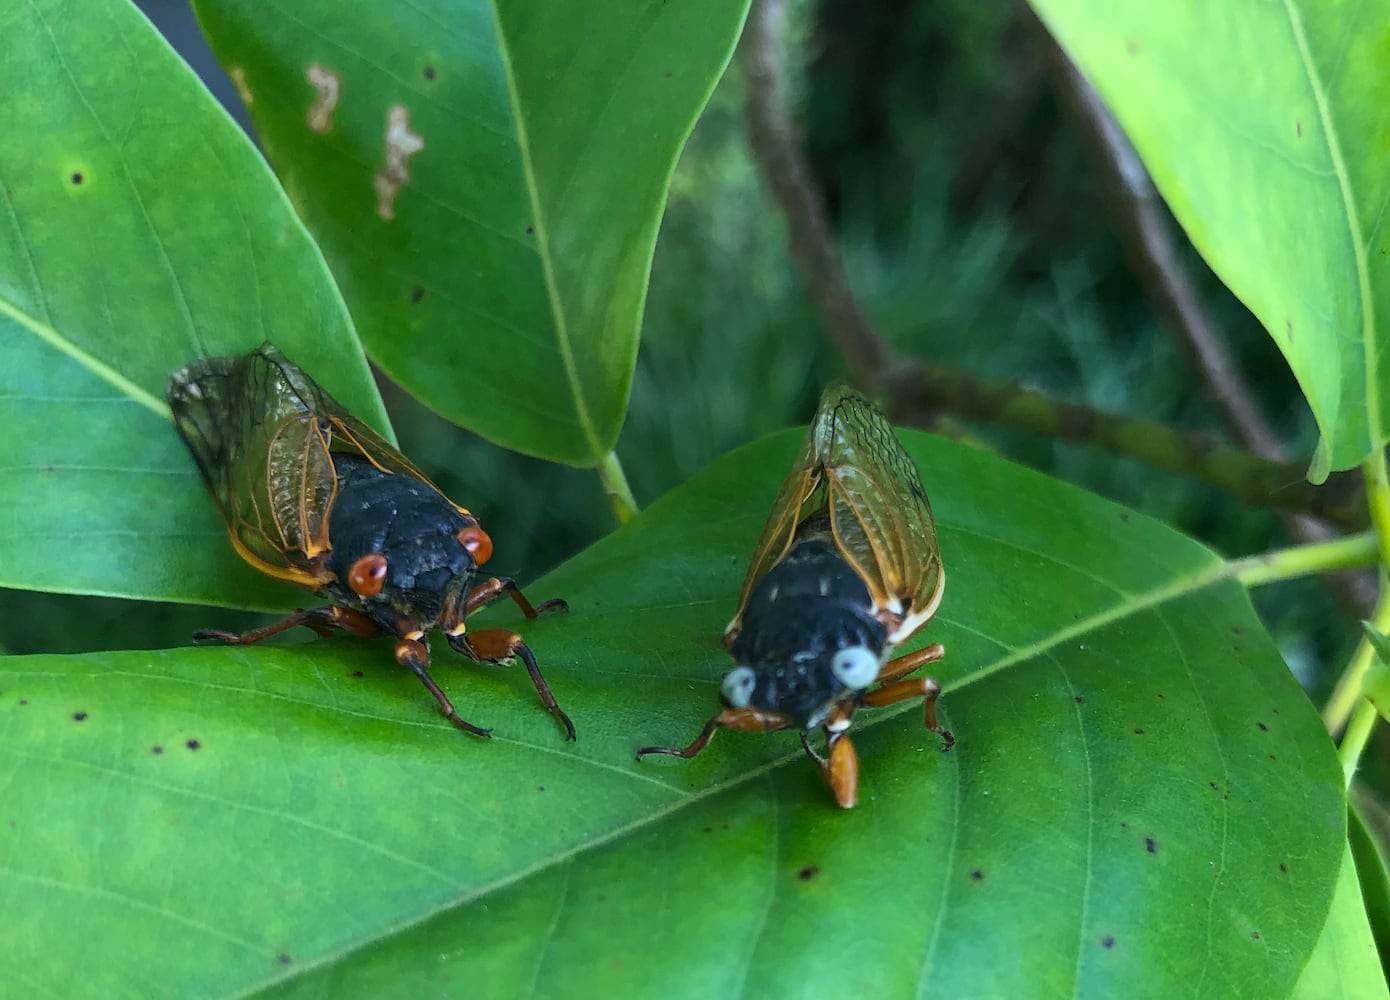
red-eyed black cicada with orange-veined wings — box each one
[168,342,574,740]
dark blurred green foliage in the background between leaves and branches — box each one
[0,0,1348,686]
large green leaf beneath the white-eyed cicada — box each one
[0,433,1346,1000]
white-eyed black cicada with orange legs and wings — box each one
[637,385,955,809]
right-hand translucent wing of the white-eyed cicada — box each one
[813,385,944,628]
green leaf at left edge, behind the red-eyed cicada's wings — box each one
[0,0,385,606]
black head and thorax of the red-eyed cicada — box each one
[324,453,478,636]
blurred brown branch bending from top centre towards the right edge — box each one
[742,0,1366,539]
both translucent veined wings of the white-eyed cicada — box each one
[730,385,945,641]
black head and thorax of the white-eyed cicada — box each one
[720,538,891,729]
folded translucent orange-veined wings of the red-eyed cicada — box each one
[168,342,467,590]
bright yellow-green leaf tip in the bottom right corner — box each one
[1293,822,1390,1000]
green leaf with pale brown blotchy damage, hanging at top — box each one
[195,0,748,466]
